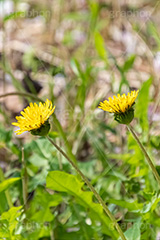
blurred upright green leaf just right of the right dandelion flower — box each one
[135,78,152,132]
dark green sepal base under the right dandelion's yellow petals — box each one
[114,108,134,125]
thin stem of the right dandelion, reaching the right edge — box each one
[127,125,160,187]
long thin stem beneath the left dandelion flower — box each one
[47,136,126,240]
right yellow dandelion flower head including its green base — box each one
[99,90,139,124]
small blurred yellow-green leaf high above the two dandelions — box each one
[94,32,108,63]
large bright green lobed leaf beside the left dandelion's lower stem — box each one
[46,171,117,237]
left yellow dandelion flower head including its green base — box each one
[12,99,55,136]
